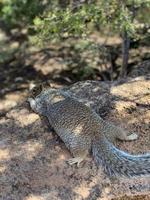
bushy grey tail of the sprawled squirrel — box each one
[92,136,150,177]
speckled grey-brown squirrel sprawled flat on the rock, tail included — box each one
[28,88,150,177]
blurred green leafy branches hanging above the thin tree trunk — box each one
[34,0,150,41]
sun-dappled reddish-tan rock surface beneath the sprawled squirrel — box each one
[0,76,150,200]
